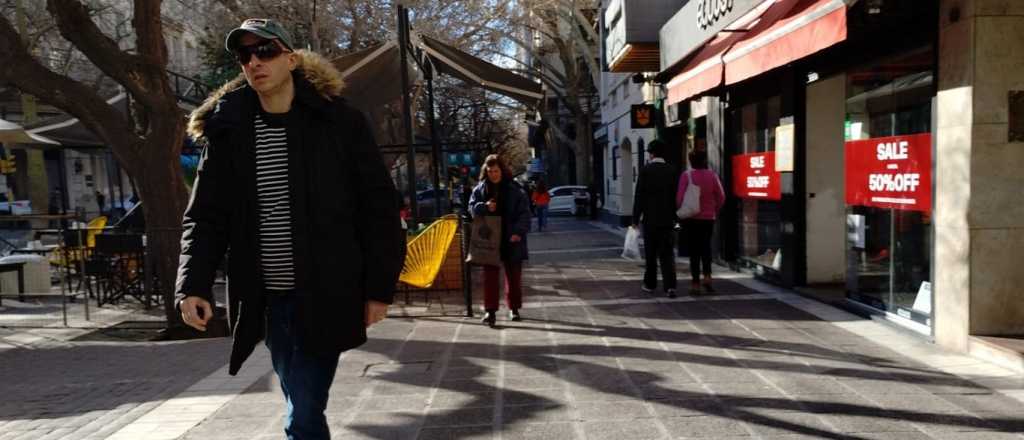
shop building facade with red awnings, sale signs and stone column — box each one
[602,0,1024,369]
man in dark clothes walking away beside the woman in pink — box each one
[633,139,678,298]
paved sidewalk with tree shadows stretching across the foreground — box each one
[0,219,1024,440]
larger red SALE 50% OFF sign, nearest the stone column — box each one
[846,133,932,212]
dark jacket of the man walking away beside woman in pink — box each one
[633,158,679,228]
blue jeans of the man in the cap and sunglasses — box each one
[266,294,341,440]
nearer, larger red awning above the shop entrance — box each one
[722,0,846,85]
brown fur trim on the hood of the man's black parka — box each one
[186,49,345,139]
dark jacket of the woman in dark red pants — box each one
[469,180,532,262]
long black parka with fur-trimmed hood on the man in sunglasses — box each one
[176,51,404,375]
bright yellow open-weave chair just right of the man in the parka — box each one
[398,214,459,289]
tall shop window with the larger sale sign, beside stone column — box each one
[845,48,935,325]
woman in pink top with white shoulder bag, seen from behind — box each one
[676,149,725,295]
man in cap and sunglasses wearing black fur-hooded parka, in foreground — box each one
[176,19,404,439]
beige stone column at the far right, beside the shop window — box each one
[934,0,1024,351]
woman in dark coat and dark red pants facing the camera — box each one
[469,155,530,326]
